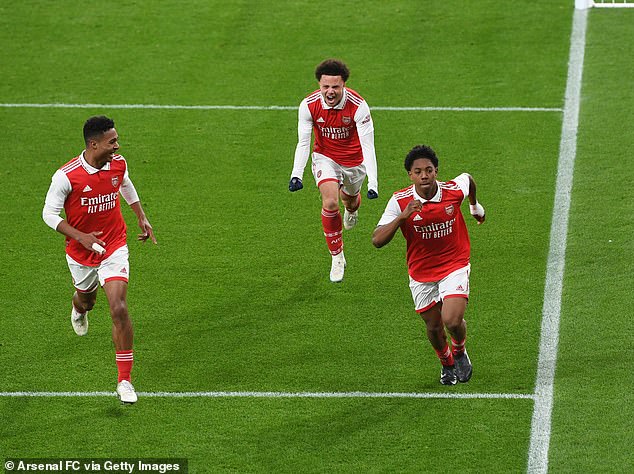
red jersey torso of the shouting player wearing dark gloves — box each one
[306,87,370,167]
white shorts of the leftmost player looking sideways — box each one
[66,245,130,293]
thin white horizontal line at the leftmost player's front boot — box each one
[0,392,534,400]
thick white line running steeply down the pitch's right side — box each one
[528,9,587,474]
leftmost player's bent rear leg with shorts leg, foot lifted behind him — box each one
[66,255,99,336]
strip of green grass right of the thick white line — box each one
[551,10,634,472]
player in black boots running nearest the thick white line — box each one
[372,145,484,385]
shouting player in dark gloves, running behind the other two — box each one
[288,59,379,282]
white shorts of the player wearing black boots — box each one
[409,264,471,313]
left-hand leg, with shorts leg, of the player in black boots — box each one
[409,277,457,385]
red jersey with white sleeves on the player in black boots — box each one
[379,174,471,282]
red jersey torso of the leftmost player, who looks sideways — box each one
[60,155,127,266]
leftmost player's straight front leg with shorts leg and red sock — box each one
[99,246,137,403]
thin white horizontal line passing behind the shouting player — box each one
[0,103,563,112]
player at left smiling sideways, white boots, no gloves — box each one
[42,116,156,403]
